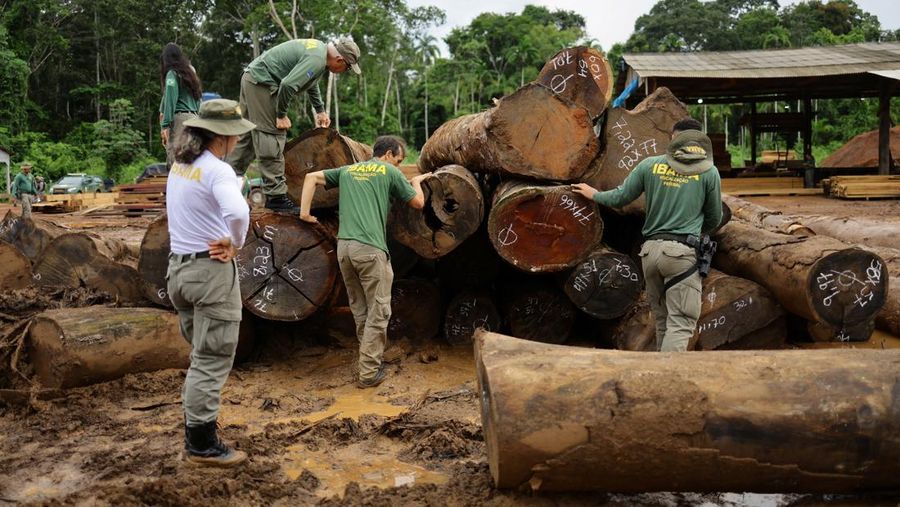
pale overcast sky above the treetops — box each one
[408,0,900,56]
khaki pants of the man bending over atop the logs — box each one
[226,72,287,196]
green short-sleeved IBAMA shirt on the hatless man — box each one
[325,158,416,252]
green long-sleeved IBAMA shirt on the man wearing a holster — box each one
[594,155,722,238]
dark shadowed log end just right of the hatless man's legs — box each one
[388,278,444,341]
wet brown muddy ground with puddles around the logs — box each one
[0,198,900,506]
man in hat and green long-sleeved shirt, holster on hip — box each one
[573,119,722,351]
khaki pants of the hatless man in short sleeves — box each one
[337,239,394,382]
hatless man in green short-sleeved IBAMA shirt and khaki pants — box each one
[300,136,431,388]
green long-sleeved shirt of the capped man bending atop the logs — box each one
[247,39,327,118]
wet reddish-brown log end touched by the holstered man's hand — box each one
[487,181,603,272]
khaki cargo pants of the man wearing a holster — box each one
[640,240,702,352]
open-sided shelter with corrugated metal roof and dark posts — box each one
[617,42,900,174]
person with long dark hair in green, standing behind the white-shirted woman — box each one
[159,42,202,169]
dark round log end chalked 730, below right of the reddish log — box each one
[563,248,644,319]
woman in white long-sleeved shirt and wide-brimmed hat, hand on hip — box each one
[166,99,256,467]
